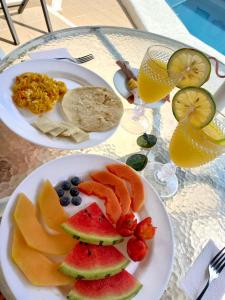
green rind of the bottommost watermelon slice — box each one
[67,282,142,300]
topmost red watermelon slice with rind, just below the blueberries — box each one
[62,202,123,245]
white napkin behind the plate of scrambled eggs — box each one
[28,48,73,59]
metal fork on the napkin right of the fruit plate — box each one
[196,247,225,300]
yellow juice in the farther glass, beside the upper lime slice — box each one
[138,59,174,102]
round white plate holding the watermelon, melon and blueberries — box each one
[0,154,174,300]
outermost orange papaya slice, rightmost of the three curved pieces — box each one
[107,164,144,212]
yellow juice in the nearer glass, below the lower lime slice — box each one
[169,123,224,168]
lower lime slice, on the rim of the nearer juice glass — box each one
[172,87,216,128]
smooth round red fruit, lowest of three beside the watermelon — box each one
[127,237,148,261]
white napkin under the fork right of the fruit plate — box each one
[180,240,225,300]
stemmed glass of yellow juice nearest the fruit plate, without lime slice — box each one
[145,113,225,198]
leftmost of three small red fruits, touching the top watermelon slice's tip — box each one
[116,213,137,236]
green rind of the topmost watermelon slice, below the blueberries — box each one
[61,223,123,245]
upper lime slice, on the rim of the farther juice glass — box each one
[167,48,211,89]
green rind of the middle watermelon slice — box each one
[59,258,130,280]
